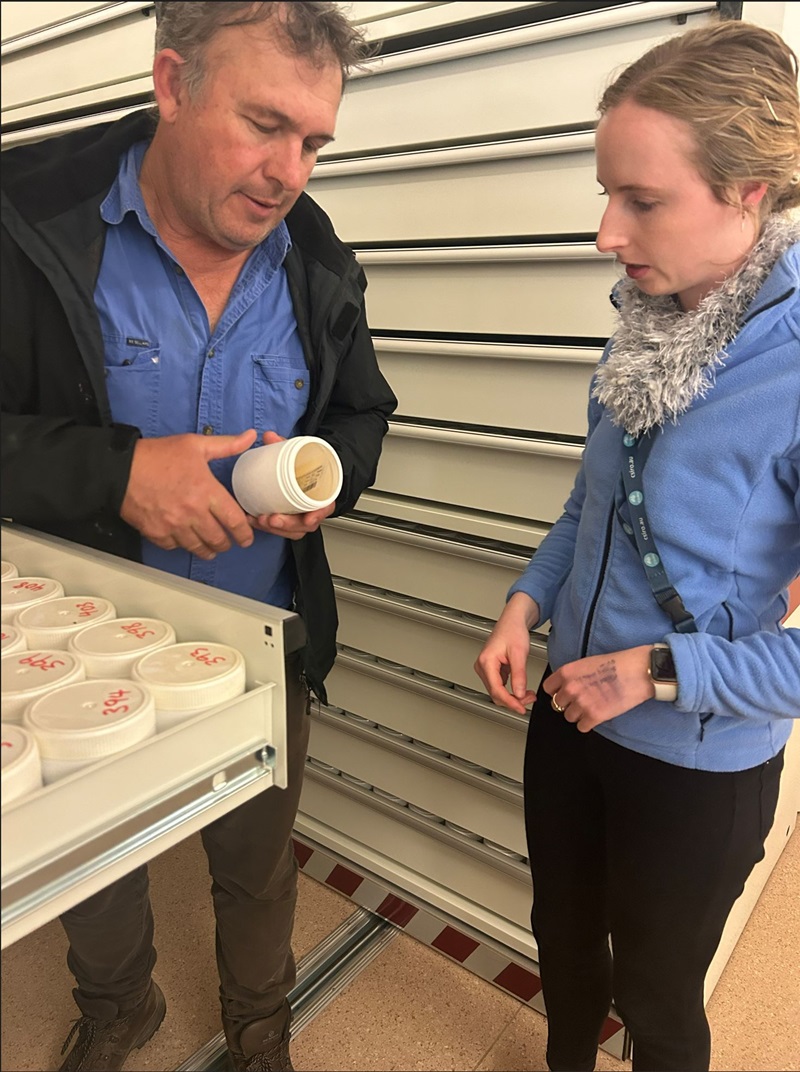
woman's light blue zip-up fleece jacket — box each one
[508,244,800,771]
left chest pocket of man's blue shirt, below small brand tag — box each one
[103,334,161,436]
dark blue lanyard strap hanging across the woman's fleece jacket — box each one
[622,432,697,632]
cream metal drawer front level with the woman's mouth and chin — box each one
[358,243,619,341]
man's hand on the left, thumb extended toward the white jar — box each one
[120,429,256,559]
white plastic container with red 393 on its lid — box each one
[131,641,247,732]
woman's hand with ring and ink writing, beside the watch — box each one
[544,644,655,733]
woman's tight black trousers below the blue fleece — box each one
[524,690,783,1072]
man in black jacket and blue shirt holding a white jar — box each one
[2,2,396,1072]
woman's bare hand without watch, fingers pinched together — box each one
[475,592,539,715]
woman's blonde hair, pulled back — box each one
[598,21,800,219]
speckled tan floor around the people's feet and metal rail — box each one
[1,830,800,1072]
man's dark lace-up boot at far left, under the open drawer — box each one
[59,982,166,1072]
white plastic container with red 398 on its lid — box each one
[66,617,175,678]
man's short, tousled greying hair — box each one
[154,0,372,95]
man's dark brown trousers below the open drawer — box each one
[61,657,309,1027]
